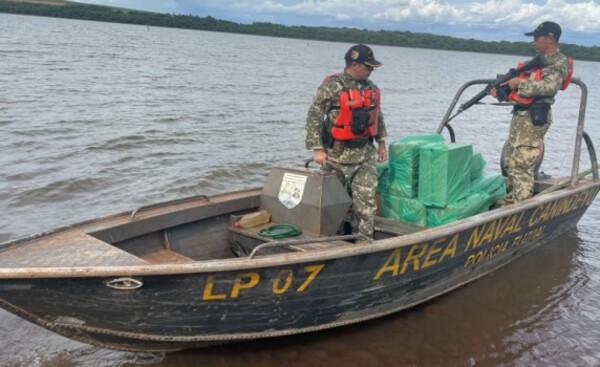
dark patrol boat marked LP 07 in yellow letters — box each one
[0,80,600,351]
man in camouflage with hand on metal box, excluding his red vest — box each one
[306,44,387,237]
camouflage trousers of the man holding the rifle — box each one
[502,111,552,203]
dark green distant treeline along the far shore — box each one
[0,0,600,61]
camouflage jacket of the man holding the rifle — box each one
[519,50,570,104]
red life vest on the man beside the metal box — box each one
[325,74,381,140]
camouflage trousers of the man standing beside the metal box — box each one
[329,157,377,237]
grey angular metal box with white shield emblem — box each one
[260,167,352,236]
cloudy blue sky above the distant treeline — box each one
[78,0,600,46]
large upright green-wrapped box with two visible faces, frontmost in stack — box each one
[418,143,473,208]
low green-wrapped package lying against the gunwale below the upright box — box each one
[427,192,496,227]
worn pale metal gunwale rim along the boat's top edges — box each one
[0,179,600,279]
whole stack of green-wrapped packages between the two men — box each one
[377,134,506,227]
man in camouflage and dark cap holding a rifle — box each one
[502,22,570,204]
